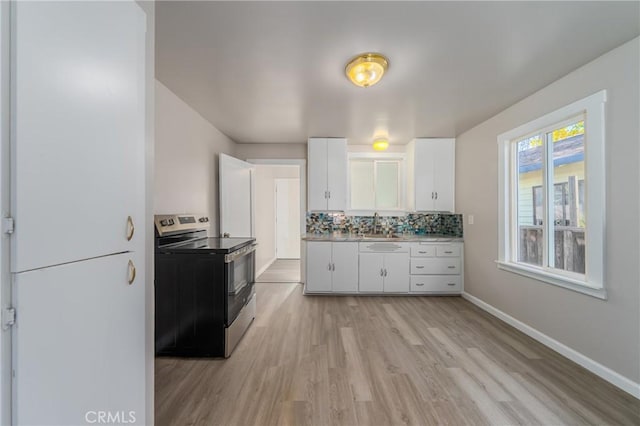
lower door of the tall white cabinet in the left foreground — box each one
[13,253,146,425]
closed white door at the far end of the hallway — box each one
[275,179,300,259]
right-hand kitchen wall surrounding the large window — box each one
[456,39,640,383]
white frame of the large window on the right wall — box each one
[496,90,607,300]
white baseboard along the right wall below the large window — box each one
[462,292,640,399]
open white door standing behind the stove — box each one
[219,154,255,237]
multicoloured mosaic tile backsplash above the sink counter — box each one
[307,213,463,237]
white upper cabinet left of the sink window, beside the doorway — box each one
[307,138,347,211]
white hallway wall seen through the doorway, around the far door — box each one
[255,164,300,273]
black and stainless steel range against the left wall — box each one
[155,215,255,357]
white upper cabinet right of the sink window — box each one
[407,138,455,212]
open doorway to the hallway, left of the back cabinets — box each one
[248,160,306,283]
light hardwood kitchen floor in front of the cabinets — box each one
[156,284,640,426]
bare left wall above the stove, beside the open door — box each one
[153,80,236,235]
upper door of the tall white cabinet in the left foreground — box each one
[12,1,146,272]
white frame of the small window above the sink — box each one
[345,152,407,216]
